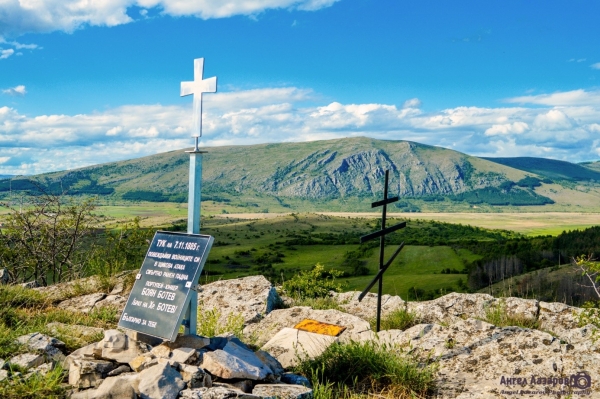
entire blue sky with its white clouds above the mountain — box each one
[0,0,600,174]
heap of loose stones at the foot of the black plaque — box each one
[65,330,312,399]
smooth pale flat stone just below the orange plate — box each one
[262,328,339,369]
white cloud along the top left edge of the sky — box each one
[0,0,339,38]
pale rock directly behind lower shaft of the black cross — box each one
[331,291,406,321]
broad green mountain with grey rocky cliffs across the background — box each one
[0,137,584,210]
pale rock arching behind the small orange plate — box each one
[244,306,371,346]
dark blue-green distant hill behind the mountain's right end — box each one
[483,157,600,181]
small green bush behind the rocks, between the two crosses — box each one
[282,263,343,300]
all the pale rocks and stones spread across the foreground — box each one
[0,277,600,399]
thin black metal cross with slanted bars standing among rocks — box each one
[358,170,406,332]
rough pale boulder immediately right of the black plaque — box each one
[198,276,280,324]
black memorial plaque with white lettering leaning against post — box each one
[119,231,214,341]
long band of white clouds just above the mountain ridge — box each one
[0,87,600,174]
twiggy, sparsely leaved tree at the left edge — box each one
[0,187,96,286]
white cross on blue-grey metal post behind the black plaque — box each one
[181,58,217,335]
